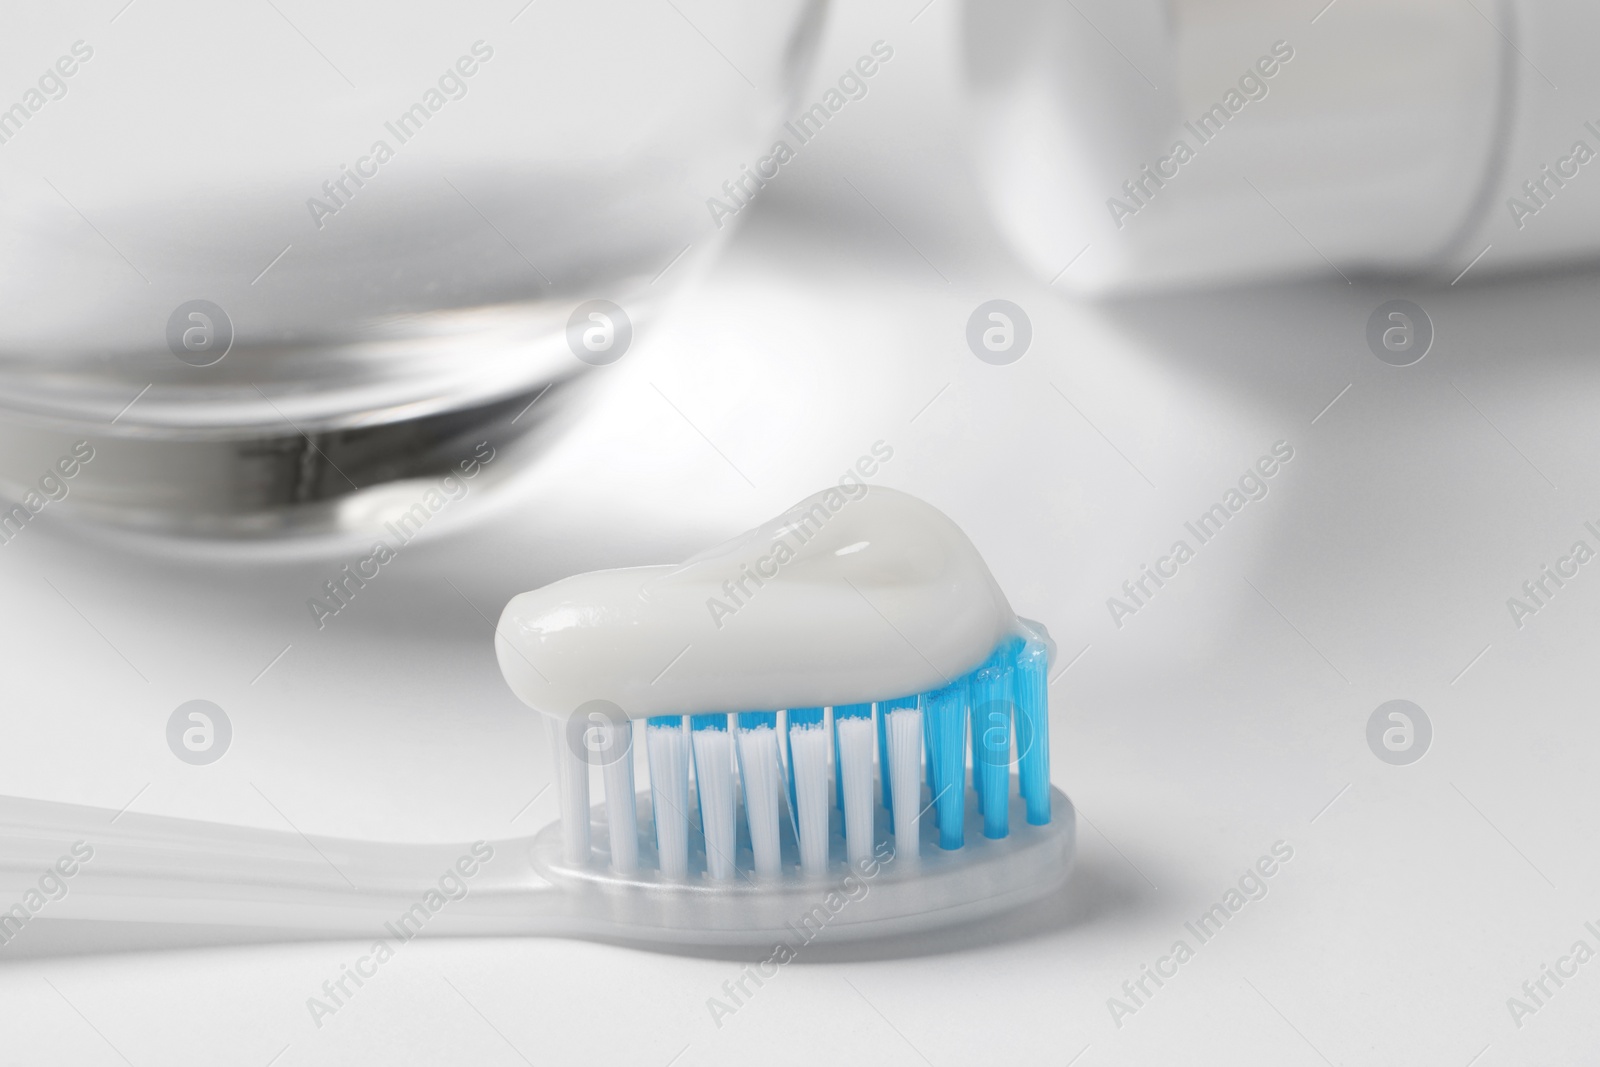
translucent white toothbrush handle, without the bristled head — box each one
[0,797,563,947]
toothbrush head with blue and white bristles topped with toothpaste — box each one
[496,485,1075,944]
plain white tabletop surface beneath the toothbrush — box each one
[0,6,1600,1067]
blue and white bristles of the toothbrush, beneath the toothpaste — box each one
[552,638,1051,881]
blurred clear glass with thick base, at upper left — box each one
[0,0,826,534]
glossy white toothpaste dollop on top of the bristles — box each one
[494,486,1032,718]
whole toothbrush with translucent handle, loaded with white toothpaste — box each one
[0,485,1075,955]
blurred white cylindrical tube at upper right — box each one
[965,0,1600,294]
